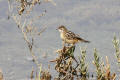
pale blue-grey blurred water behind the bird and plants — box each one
[0,0,120,80]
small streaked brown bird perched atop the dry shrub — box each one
[58,25,90,45]
